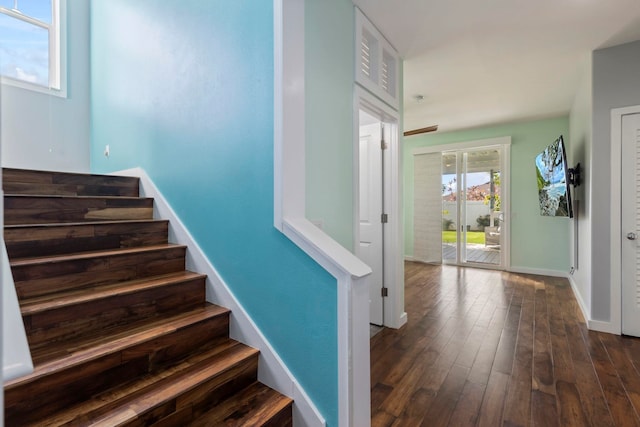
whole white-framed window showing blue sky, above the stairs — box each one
[0,0,64,95]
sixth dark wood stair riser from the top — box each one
[5,315,229,425]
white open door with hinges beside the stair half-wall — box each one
[357,122,384,325]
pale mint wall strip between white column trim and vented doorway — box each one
[305,0,355,251]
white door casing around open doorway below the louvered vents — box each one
[352,85,407,329]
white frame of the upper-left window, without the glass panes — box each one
[0,0,67,98]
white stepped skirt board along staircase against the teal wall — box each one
[113,168,326,427]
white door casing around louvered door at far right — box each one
[607,105,640,335]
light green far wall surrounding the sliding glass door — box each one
[403,117,570,272]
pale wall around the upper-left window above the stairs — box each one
[0,0,90,172]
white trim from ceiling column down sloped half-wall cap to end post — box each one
[273,0,371,427]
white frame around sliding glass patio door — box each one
[411,136,511,271]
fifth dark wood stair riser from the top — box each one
[23,279,205,349]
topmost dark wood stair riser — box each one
[2,169,140,197]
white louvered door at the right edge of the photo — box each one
[621,114,640,337]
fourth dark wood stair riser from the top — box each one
[12,247,185,298]
